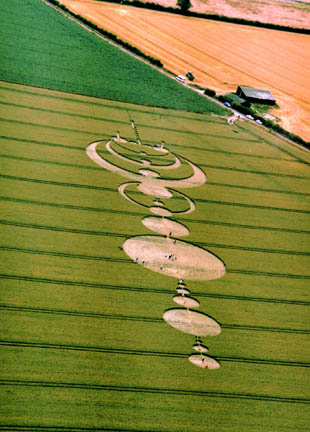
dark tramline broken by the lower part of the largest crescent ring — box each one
[0,148,310,197]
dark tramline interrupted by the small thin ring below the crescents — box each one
[0,174,310,214]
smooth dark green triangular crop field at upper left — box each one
[0,0,225,114]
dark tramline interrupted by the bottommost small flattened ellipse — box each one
[0,340,310,368]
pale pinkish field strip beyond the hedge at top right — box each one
[144,0,310,28]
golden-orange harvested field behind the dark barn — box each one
[62,0,310,141]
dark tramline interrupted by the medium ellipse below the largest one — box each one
[0,304,310,334]
